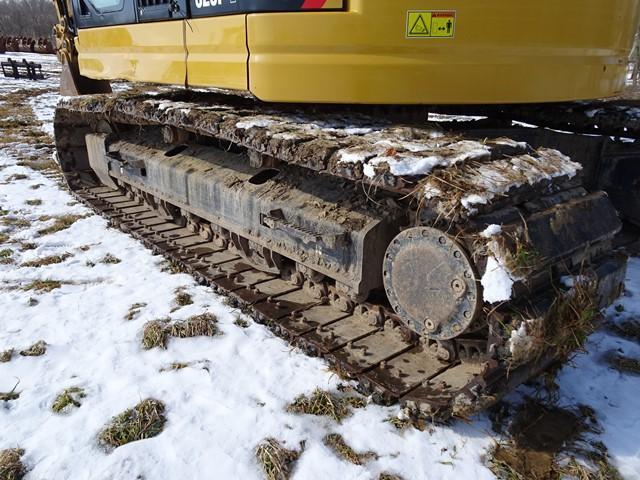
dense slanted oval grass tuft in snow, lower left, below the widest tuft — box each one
[98,398,166,449]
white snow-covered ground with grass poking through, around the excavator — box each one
[0,54,640,480]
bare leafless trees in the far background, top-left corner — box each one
[0,0,57,37]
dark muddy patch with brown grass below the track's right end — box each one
[488,401,620,480]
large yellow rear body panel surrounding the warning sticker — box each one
[247,0,640,104]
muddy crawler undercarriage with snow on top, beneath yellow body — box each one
[55,91,635,418]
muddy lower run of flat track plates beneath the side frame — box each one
[74,187,492,417]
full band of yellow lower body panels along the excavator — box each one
[72,0,640,104]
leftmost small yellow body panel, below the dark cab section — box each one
[76,22,186,85]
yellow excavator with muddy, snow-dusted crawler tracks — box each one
[54,0,640,418]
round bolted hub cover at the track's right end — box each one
[383,227,482,340]
